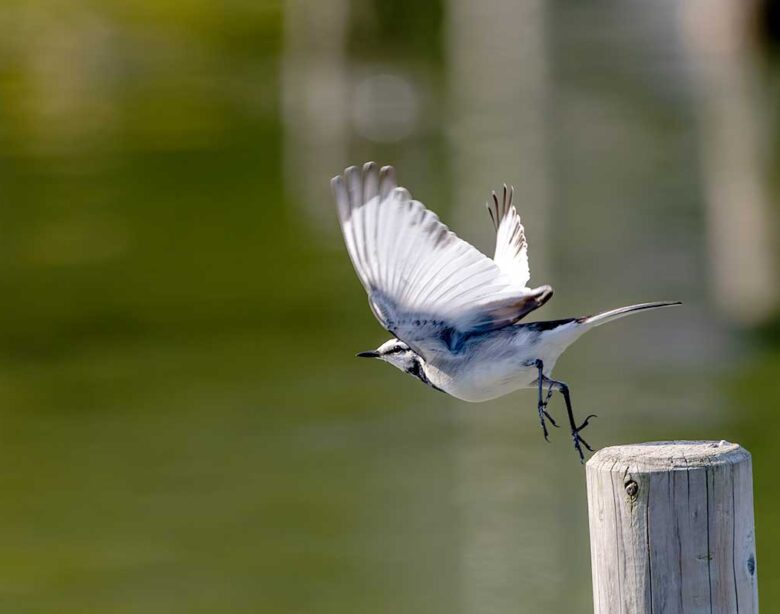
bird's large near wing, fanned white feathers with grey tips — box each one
[331,162,552,360]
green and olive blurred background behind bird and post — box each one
[0,0,780,614]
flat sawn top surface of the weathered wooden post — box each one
[588,441,750,471]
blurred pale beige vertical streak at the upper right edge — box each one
[680,0,780,324]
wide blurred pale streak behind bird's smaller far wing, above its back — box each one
[446,0,551,276]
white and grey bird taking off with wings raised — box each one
[331,162,681,462]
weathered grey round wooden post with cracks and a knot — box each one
[586,441,758,614]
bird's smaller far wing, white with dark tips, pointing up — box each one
[485,184,531,288]
